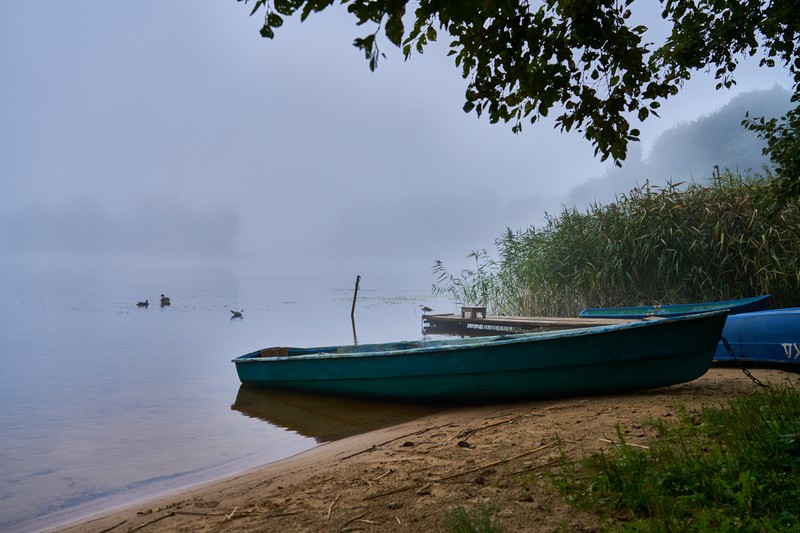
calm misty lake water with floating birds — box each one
[0,256,452,531]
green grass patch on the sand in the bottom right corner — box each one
[554,385,800,531]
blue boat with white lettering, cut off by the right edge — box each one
[714,307,800,366]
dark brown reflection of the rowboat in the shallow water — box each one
[231,385,438,443]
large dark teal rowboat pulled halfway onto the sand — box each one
[233,311,727,402]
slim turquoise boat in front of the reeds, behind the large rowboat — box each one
[578,294,770,319]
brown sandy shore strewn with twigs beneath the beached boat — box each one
[58,368,800,533]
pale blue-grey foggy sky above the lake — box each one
[0,0,789,284]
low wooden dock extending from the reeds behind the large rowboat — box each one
[422,313,637,335]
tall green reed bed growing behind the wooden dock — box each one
[434,172,800,316]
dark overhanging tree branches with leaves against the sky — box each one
[239,0,800,200]
